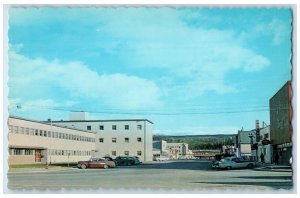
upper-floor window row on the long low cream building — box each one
[9,125,95,142]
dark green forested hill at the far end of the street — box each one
[153,134,236,150]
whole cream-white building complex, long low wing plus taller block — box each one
[8,113,153,164]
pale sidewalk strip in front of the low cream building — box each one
[7,166,78,174]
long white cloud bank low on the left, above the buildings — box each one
[9,51,161,109]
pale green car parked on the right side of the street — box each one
[212,157,256,169]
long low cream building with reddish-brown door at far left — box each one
[8,116,96,165]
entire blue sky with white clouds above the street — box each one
[8,8,292,135]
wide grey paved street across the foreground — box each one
[7,160,293,193]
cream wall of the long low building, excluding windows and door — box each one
[8,118,95,164]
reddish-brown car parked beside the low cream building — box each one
[77,158,116,169]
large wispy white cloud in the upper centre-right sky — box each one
[95,9,270,97]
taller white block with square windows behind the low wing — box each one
[52,119,153,161]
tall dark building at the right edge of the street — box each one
[269,81,293,165]
